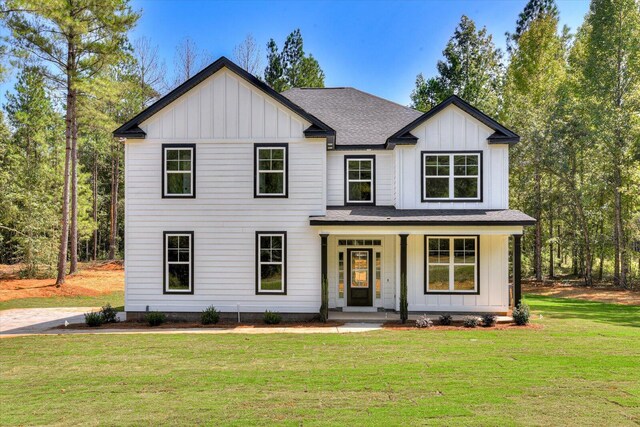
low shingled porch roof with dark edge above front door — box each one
[309,206,536,226]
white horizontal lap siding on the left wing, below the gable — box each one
[126,141,325,312]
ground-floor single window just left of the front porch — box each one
[256,231,287,294]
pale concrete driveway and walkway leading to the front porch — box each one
[0,307,382,338]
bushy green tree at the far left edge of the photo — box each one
[0,67,63,277]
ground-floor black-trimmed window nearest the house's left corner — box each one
[164,231,193,294]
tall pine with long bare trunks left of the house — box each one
[2,0,138,285]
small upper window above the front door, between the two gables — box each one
[344,156,376,205]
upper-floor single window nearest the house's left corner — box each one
[162,144,196,198]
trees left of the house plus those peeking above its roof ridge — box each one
[0,0,324,285]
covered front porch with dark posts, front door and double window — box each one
[311,207,531,318]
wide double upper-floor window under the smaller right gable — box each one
[422,152,482,202]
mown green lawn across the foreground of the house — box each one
[0,296,640,426]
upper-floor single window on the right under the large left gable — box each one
[254,144,289,197]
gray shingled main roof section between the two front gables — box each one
[282,87,422,146]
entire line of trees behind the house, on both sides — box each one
[0,0,640,287]
